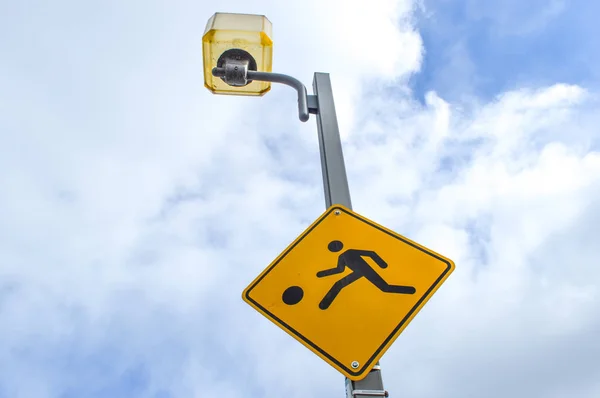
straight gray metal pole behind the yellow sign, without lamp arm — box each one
[313,73,388,398]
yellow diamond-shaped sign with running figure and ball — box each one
[243,205,454,380]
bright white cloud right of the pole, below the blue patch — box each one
[349,81,600,396]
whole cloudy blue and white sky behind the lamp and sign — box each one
[0,0,600,398]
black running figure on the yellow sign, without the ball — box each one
[317,240,416,310]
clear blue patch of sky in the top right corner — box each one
[413,0,600,103]
